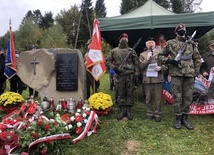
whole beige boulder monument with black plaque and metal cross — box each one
[17,48,86,105]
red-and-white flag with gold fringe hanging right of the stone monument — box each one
[86,19,106,81]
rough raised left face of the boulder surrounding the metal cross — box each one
[17,49,55,91]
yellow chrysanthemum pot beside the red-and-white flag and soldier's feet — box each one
[88,92,113,115]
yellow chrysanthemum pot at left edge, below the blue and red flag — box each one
[0,92,24,113]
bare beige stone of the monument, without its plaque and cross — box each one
[17,48,86,104]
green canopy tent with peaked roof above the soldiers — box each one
[98,0,214,52]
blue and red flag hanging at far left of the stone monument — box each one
[4,22,17,79]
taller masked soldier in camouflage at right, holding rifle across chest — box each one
[161,23,201,130]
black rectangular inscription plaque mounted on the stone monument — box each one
[56,53,78,91]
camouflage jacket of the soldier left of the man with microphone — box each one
[106,47,138,75]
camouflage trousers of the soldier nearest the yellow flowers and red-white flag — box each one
[116,74,134,106]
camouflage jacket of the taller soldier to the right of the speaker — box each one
[160,37,201,77]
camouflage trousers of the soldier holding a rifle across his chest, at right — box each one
[171,77,194,115]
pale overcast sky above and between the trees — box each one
[0,0,214,36]
